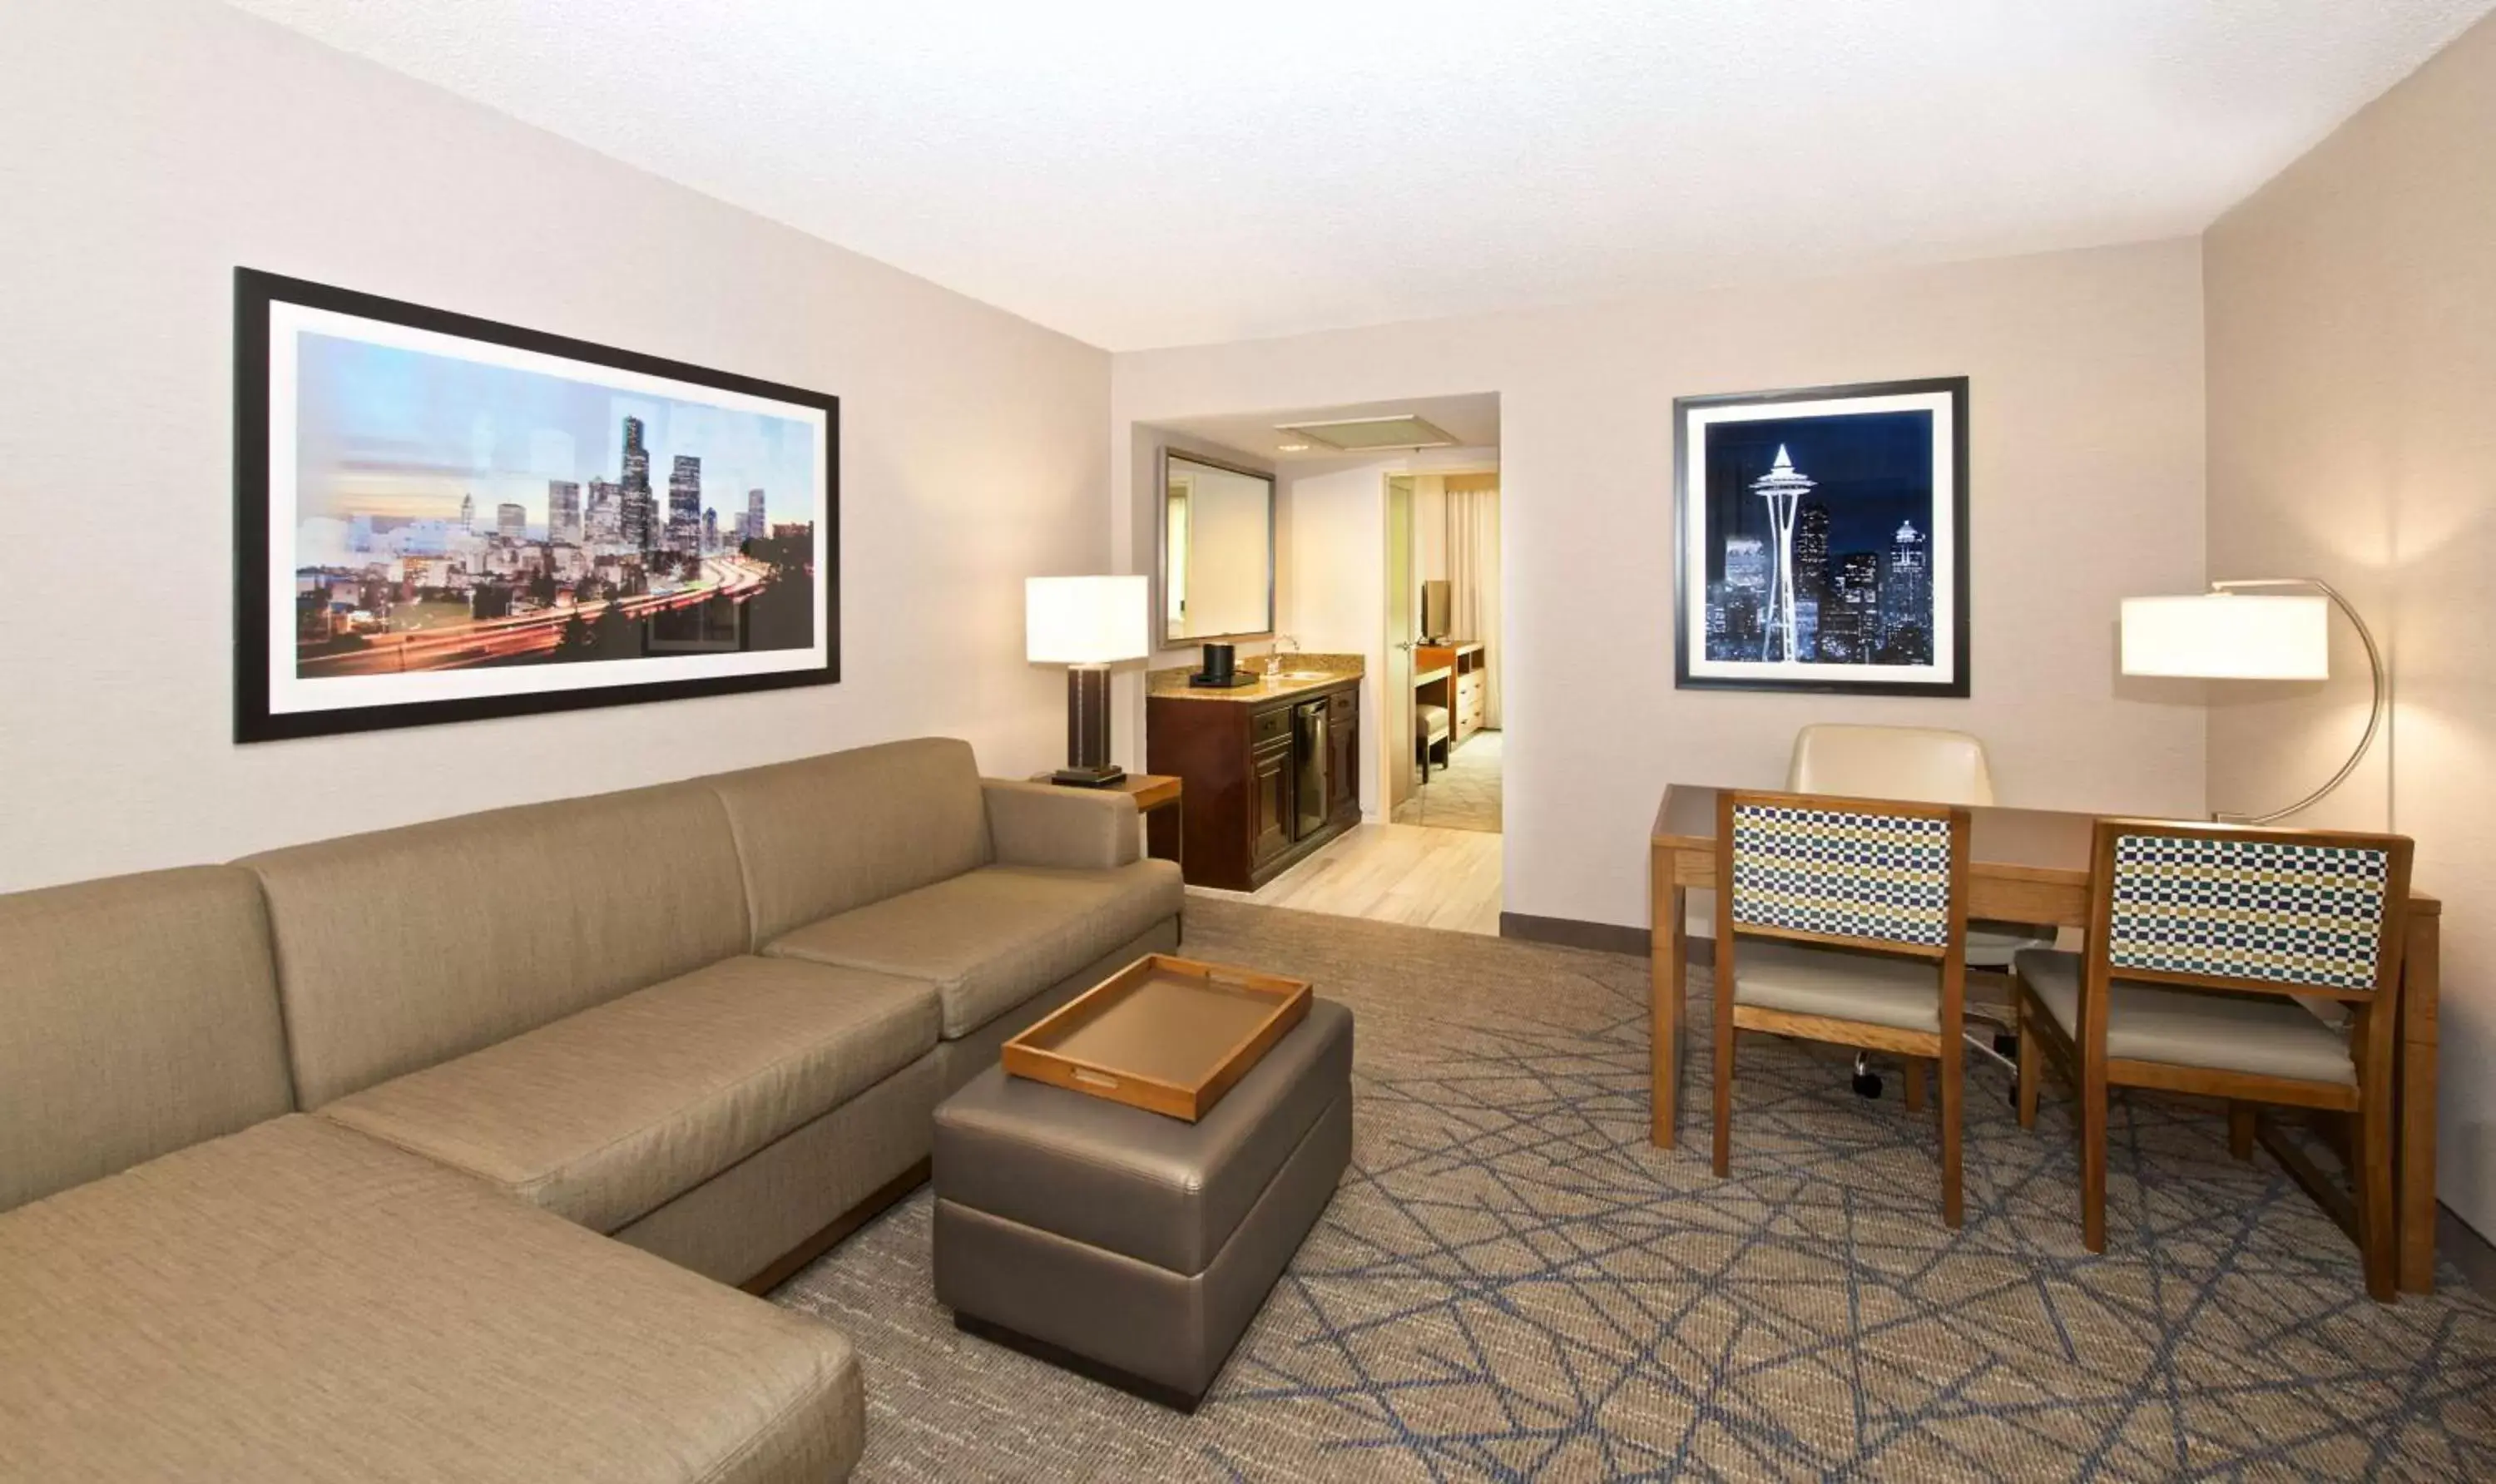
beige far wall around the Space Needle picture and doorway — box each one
[1111,242,2204,925]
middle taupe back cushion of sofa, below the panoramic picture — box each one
[242,783,749,1107]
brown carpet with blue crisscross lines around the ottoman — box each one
[776,900,2496,1484]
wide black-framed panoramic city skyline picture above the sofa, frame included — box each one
[235,270,841,743]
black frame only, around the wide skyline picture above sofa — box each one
[232,267,841,743]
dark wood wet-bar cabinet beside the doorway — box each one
[1143,676,1360,890]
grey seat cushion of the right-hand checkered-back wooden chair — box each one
[2017,950,2356,1085]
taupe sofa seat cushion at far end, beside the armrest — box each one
[764,860,1183,1040]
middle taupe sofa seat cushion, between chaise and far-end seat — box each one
[322,957,936,1232]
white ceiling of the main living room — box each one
[235,0,2496,349]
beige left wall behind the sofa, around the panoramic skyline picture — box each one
[0,0,1108,888]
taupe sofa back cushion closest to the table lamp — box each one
[704,739,991,942]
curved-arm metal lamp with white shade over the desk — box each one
[2122,576,2391,825]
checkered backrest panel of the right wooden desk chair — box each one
[2107,835,2391,990]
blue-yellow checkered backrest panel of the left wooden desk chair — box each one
[1732,803,1949,947]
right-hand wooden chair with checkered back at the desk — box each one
[2014,820,2411,1302]
